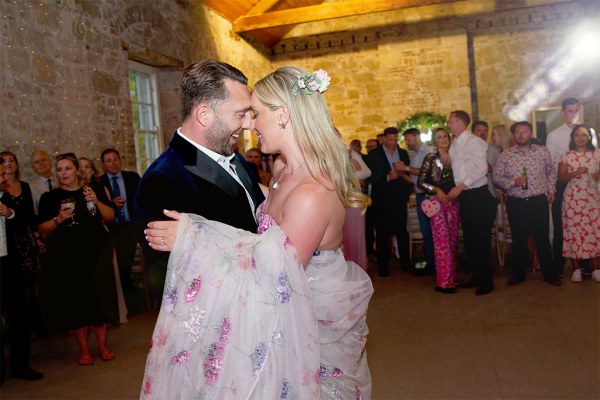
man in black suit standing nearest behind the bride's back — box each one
[367,127,413,277]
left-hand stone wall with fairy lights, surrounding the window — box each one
[0,0,271,179]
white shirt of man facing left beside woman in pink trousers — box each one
[449,131,487,190]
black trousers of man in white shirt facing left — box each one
[460,184,498,288]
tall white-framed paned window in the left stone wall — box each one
[129,61,162,174]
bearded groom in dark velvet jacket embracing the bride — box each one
[135,60,264,301]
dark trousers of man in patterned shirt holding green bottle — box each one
[506,194,558,280]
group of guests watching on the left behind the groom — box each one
[0,149,140,381]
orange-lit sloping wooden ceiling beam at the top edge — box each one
[233,0,464,32]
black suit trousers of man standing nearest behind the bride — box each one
[374,201,410,268]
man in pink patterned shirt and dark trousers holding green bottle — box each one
[493,121,560,286]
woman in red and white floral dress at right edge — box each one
[558,125,600,282]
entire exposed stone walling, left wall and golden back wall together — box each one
[0,0,600,174]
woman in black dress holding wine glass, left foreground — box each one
[38,153,116,365]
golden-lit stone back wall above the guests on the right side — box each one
[273,0,600,145]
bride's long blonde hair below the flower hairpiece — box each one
[254,66,371,209]
